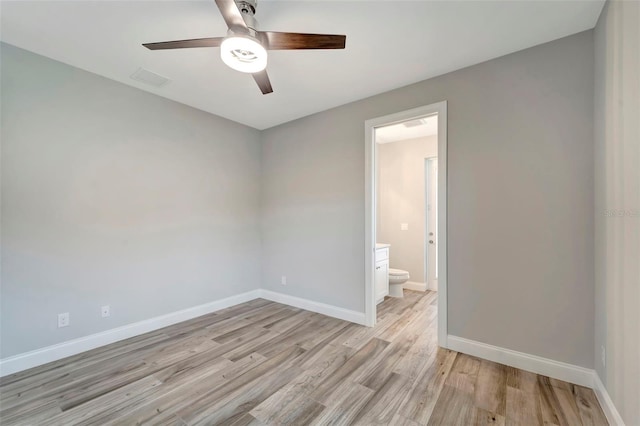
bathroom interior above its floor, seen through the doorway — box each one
[374,115,438,311]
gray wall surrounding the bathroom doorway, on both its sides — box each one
[262,31,594,367]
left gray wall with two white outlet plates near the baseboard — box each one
[0,44,260,357]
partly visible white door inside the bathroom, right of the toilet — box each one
[426,157,438,291]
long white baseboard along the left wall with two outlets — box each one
[0,290,260,377]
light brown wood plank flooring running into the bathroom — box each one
[0,291,607,426]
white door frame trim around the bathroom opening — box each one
[364,101,448,348]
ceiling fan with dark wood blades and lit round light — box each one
[143,0,346,95]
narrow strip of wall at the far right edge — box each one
[594,1,640,425]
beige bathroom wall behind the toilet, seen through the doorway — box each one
[376,135,438,284]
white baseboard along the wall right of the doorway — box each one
[447,335,594,388]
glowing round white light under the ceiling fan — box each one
[220,35,267,73]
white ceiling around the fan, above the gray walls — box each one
[0,0,604,129]
